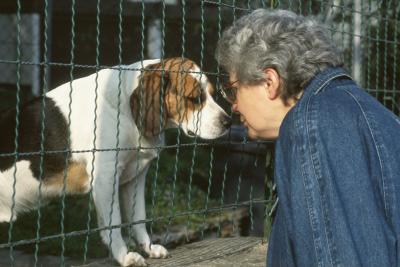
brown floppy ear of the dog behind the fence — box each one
[130,63,169,137]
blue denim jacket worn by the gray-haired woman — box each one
[267,68,400,267]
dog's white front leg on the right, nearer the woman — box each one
[121,165,168,258]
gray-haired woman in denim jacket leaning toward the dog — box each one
[216,9,400,267]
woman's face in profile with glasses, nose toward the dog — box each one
[230,71,293,140]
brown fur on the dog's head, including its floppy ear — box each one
[130,58,205,137]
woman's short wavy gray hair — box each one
[216,9,343,103]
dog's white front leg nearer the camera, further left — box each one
[93,166,146,266]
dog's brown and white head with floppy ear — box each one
[130,58,231,139]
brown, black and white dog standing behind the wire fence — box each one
[0,58,230,266]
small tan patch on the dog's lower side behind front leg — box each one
[44,162,89,194]
